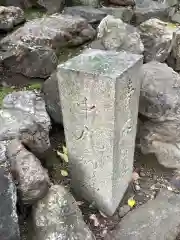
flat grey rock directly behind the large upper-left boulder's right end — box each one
[63,6,107,23]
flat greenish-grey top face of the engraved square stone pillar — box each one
[58,49,143,78]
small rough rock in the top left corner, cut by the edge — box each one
[0,6,25,31]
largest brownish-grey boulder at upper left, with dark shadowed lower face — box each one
[0,14,95,78]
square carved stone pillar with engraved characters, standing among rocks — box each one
[58,49,142,215]
